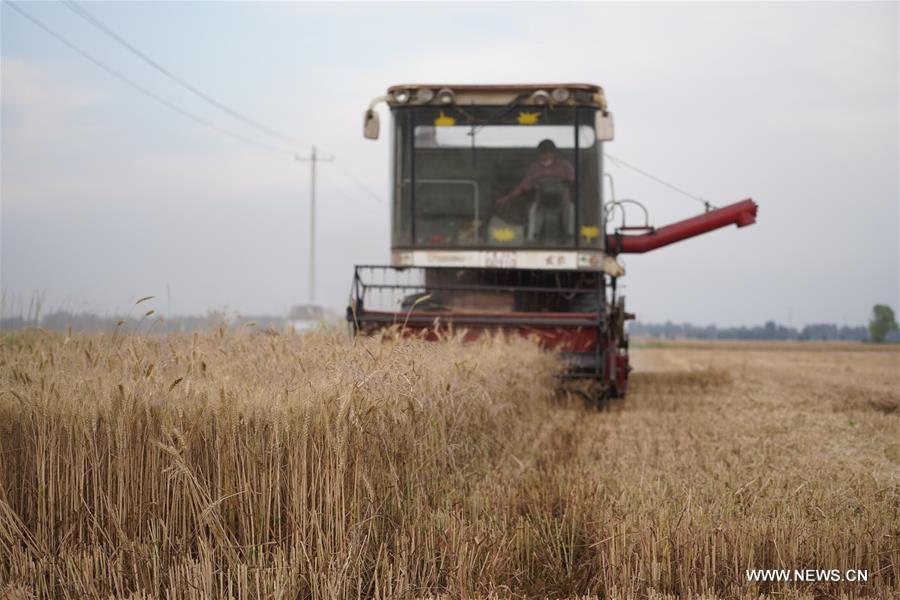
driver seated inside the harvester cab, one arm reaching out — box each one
[497,140,575,243]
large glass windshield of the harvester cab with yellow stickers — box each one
[393,106,603,249]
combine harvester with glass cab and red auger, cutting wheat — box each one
[347,84,757,401]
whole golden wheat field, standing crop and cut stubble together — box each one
[0,328,900,599]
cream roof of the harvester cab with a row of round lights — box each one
[387,83,606,111]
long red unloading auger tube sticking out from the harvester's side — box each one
[606,198,758,254]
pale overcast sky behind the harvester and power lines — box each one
[0,2,900,326]
